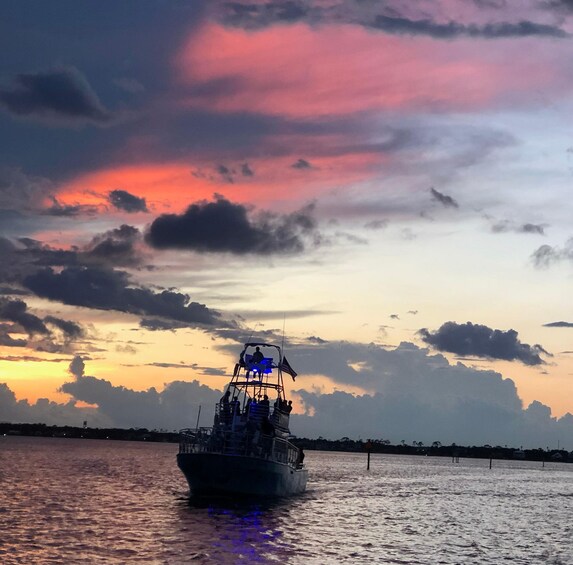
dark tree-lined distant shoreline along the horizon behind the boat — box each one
[0,422,573,463]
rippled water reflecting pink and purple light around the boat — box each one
[0,437,573,565]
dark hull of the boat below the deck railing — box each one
[177,453,308,496]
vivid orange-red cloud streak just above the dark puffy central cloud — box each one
[54,153,384,214]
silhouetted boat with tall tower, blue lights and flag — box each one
[177,342,308,497]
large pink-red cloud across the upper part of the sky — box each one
[177,24,559,117]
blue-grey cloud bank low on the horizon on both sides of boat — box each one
[4,338,573,447]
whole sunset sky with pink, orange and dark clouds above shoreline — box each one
[0,0,573,450]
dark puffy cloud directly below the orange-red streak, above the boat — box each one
[145,197,318,255]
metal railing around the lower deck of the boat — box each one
[179,428,301,468]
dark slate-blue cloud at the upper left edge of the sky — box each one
[0,67,112,125]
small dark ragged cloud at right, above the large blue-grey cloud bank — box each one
[419,322,547,365]
